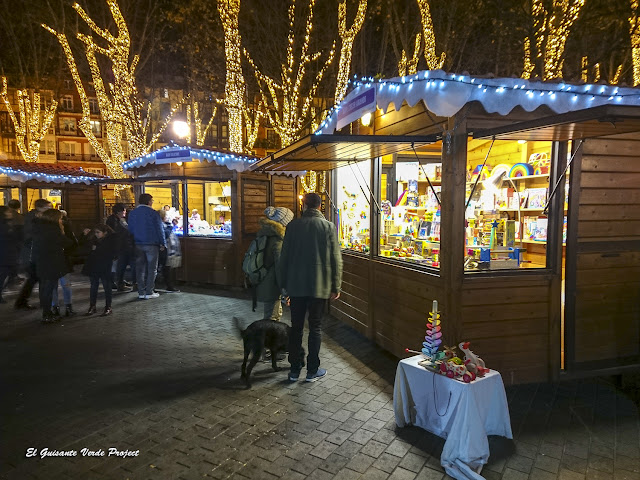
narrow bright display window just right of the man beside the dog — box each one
[335,162,371,253]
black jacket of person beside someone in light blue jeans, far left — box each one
[32,222,73,280]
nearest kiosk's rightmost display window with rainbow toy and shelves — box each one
[465,140,551,271]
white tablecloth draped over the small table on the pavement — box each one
[393,355,513,479]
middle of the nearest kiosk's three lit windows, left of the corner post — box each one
[378,155,442,268]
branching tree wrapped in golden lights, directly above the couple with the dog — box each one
[244,0,336,147]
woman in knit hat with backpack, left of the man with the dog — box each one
[256,207,293,321]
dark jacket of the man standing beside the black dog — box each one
[278,208,342,298]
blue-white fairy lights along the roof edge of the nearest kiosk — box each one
[315,70,640,135]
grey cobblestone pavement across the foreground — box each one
[0,277,640,480]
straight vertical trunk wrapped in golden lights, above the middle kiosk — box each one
[218,0,246,153]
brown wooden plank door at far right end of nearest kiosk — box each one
[565,134,640,374]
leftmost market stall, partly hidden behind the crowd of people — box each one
[0,159,106,234]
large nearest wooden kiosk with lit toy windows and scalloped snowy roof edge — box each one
[251,71,640,384]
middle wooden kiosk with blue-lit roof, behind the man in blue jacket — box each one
[123,146,299,287]
